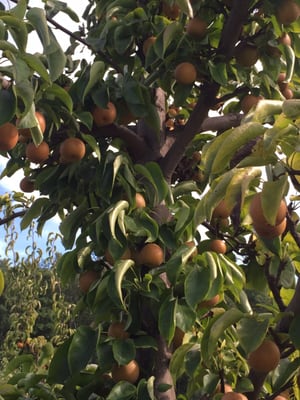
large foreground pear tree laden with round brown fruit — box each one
[0,0,300,400]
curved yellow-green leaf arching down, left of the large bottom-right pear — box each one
[201,308,245,362]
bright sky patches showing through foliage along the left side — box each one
[0,0,88,258]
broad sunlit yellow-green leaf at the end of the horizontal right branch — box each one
[211,122,266,174]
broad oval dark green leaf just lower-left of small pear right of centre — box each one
[184,265,211,308]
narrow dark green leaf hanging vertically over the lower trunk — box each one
[158,296,177,343]
